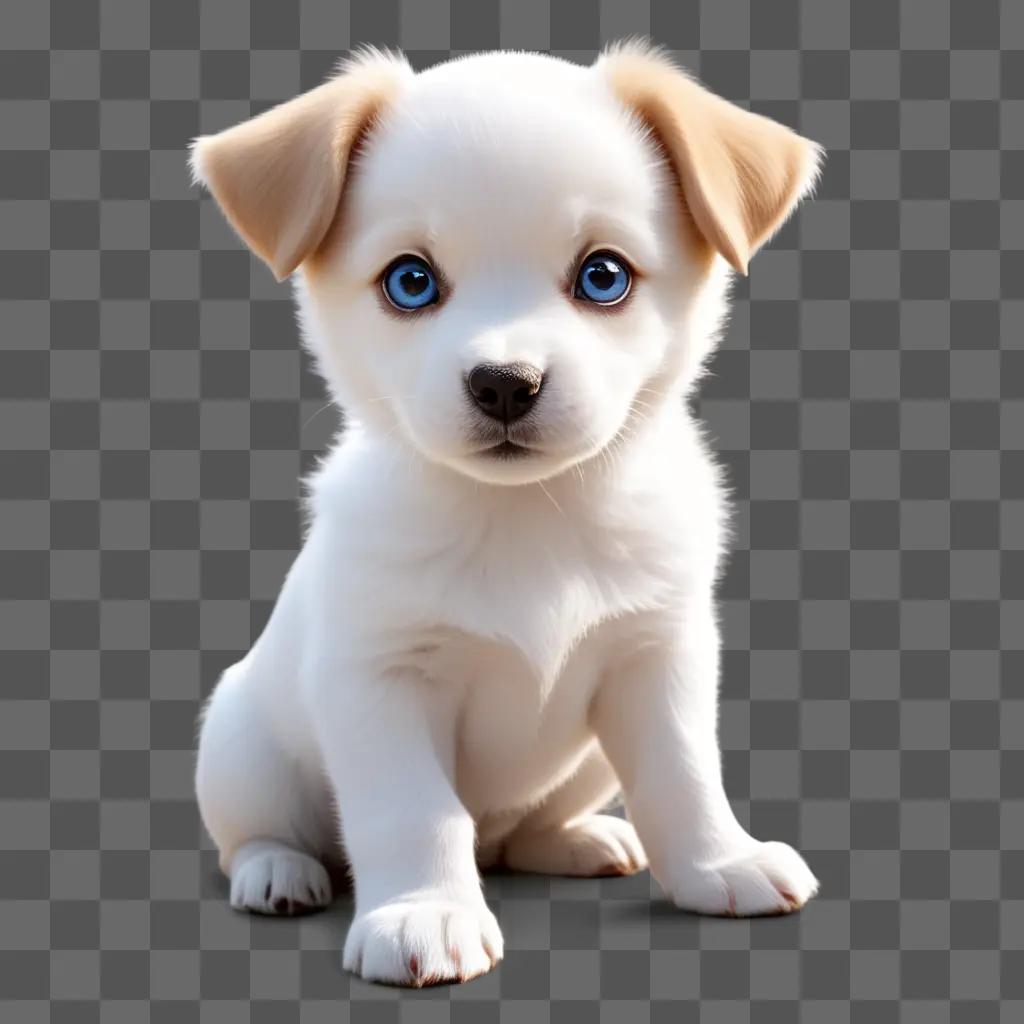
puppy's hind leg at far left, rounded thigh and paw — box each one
[196,659,333,914]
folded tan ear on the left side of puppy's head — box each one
[191,50,413,281]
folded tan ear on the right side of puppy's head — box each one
[595,43,822,273]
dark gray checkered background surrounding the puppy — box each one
[0,0,1024,1024]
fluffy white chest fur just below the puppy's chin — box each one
[310,414,721,691]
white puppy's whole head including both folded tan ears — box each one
[193,45,818,483]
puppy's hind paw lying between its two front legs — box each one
[505,814,647,878]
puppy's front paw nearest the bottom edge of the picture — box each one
[342,894,504,988]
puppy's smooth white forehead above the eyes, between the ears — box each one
[351,54,660,262]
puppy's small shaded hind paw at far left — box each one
[231,841,331,914]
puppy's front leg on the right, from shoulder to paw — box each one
[593,603,818,915]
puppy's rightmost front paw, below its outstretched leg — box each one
[669,843,818,918]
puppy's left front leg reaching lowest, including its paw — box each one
[317,673,502,985]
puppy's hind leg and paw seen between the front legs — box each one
[504,743,647,878]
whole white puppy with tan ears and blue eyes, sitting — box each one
[193,44,819,985]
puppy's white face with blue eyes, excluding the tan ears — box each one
[306,56,696,483]
